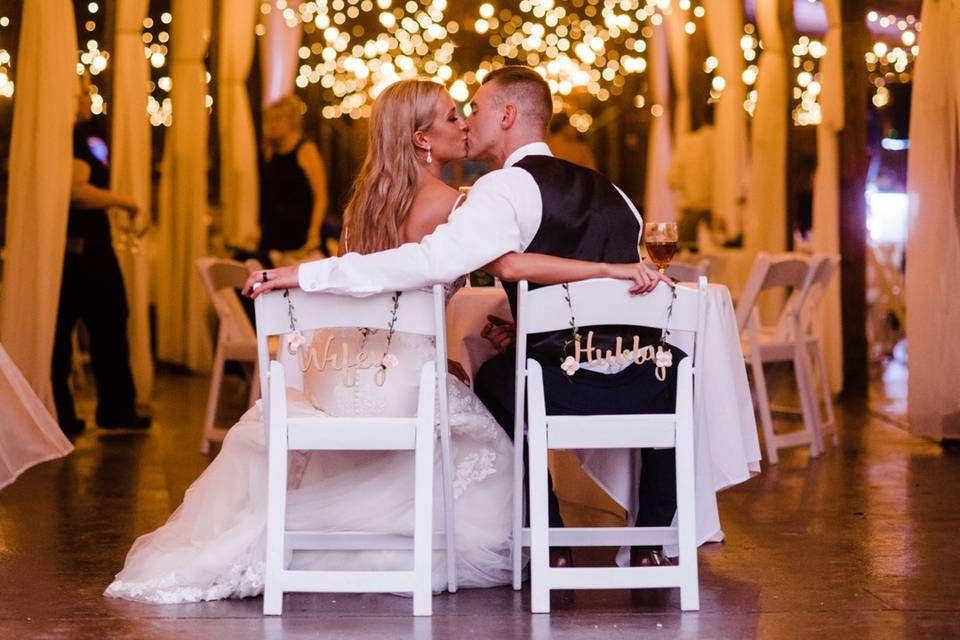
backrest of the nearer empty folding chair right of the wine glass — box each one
[736,252,813,333]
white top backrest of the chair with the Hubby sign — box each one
[517,276,707,370]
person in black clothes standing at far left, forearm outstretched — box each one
[51,76,150,435]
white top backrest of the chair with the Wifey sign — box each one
[254,284,447,415]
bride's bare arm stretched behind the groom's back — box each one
[484,253,673,293]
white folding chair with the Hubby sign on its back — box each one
[513,277,707,613]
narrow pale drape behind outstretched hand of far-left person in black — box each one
[110,0,153,404]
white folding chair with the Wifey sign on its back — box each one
[256,285,457,616]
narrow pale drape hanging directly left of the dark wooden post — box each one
[813,0,844,393]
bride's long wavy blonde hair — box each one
[340,80,444,253]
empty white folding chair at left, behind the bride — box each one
[196,257,260,454]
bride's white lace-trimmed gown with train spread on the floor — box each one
[105,329,513,603]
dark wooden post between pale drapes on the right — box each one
[839,0,870,398]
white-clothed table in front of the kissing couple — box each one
[447,283,760,551]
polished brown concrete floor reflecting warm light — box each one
[0,373,960,640]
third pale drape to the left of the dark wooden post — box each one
[704,0,749,236]
